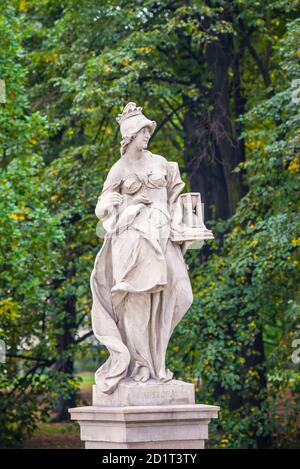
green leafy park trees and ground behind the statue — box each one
[0,0,300,448]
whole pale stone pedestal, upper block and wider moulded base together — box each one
[69,378,219,449]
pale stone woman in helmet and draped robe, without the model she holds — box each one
[91,103,212,394]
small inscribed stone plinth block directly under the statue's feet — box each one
[93,378,195,407]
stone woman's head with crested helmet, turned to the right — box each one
[116,103,156,156]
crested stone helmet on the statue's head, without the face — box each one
[116,103,156,139]
